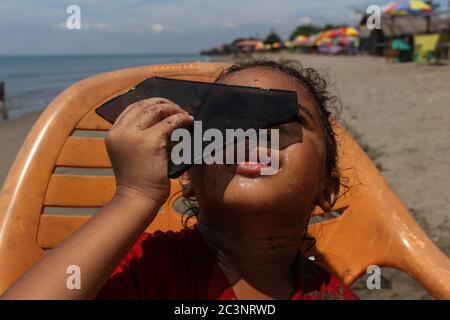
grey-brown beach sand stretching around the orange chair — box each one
[0,53,450,299]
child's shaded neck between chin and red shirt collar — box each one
[197,215,303,298]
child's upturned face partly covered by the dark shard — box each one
[183,67,326,230]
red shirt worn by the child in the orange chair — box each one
[97,228,357,300]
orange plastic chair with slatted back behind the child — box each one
[0,63,450,299]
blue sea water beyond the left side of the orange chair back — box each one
[0,53,209,118]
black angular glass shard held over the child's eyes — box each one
[96,77,299,178]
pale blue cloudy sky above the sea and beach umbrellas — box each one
[0,0,447,55]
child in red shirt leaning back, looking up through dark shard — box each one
[0,61,356,299]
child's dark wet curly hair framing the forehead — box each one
[183,59,340,227]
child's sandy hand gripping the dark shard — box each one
[105,98,193,205]
